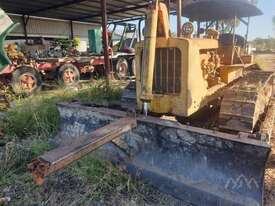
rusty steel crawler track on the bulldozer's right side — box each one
[219,70,274,133]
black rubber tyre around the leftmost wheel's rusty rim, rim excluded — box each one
[11,66,42,96]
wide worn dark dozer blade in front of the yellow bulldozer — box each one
[58,103,270,206]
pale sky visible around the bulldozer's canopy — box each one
[170,0,275,40]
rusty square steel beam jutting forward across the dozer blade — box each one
[27,117,137,185]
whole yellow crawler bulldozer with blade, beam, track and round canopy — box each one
[28,0,275,206]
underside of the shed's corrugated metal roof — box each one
[0,0,151,23]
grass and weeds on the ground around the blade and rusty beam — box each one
[0,82,190,206]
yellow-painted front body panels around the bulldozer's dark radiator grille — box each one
[136,4,247,117]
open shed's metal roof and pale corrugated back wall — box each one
[0,0,153,39]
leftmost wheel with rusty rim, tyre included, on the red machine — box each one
[11,66,42,95]
